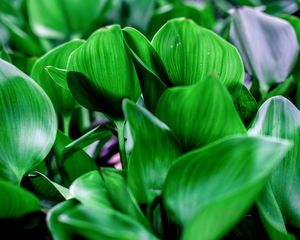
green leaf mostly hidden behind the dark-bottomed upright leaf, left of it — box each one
[30,40,84,115]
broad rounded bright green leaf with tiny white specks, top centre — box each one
[152,18,244,95]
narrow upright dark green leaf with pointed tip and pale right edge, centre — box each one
[123,101,180,204]
